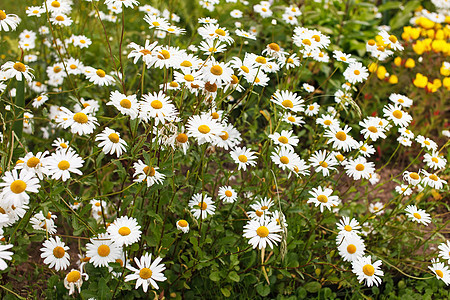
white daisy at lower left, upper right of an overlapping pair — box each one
[106,216,142,246]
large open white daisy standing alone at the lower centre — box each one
[243,218,282,249]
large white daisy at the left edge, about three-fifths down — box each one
[0,169,40,206]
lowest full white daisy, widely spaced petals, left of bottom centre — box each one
[125,253,167,292]
